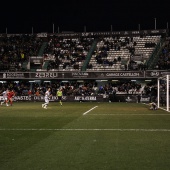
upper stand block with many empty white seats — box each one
[87,36,161,71]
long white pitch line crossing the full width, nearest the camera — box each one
[0,129,170,132]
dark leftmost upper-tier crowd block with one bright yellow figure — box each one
[0,34,42,71]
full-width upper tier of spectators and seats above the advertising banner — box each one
[0,34,170,71]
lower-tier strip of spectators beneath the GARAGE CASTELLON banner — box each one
[0,80,157,99]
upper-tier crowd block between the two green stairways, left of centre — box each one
[44,35,94,70]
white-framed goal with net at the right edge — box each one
[157,75,170,112]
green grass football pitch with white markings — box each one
[0,102,170,170]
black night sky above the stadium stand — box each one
[0,0,170,34]
